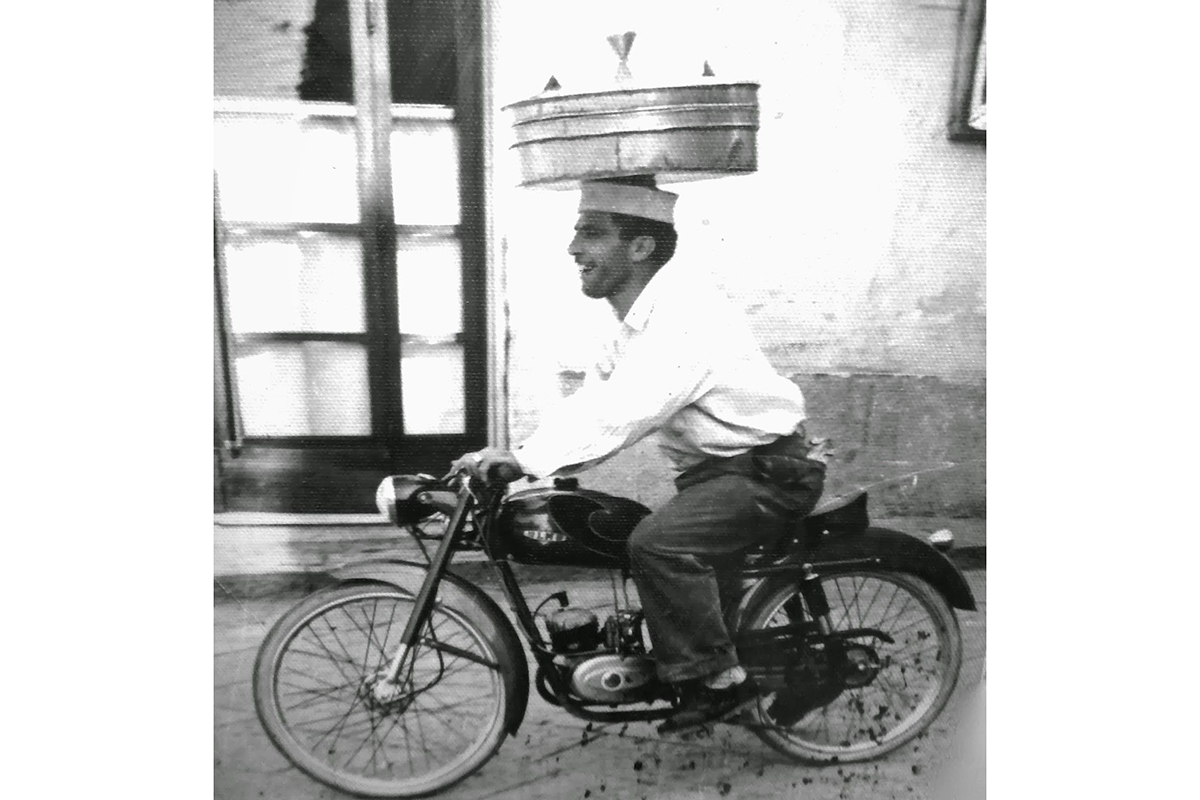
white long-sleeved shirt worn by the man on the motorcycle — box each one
[515,261,805,477]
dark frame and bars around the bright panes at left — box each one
[214,0,491,511]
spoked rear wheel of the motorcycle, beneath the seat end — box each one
[744,571,962,764]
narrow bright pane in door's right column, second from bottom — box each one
[396,239,462,341]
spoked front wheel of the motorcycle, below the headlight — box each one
[253,584,511,798]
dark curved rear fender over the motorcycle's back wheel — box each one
[730,528,977,630]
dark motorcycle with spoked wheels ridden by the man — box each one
[253,465,976,798]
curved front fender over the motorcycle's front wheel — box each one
[330,559,529,735]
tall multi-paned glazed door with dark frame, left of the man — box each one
[214,0,486,511]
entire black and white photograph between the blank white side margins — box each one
[212,0,988,800]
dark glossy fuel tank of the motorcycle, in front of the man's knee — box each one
[492,481,650,569]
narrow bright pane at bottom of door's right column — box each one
[400,342,466,434]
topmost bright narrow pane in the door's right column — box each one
[391,119,458,225]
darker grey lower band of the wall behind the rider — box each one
[561,374,986,518]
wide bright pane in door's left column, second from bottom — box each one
[226,231,366,333]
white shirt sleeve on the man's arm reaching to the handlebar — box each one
[515,326,712,477]
